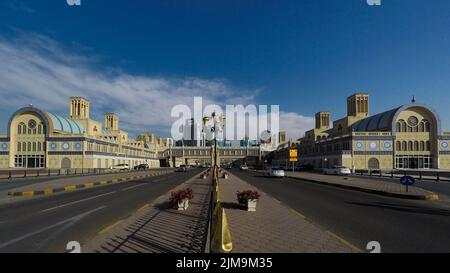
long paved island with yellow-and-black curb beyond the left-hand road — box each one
[0,170,170,199]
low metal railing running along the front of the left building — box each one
[0,168,173,180]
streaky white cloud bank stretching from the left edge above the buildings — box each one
[0,33,311,138]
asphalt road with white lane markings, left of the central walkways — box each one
[0,170,200,253]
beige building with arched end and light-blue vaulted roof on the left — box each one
[0,97,159,169]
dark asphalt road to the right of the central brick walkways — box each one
[232,170,450,253]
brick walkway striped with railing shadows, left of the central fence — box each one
[82,171,212,253]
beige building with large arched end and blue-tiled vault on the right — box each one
[282,93,450,170]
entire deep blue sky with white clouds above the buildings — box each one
[0,0,450,137]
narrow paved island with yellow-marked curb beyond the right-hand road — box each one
[286,171,439,201]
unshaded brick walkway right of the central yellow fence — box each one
[220,175,359,253]
